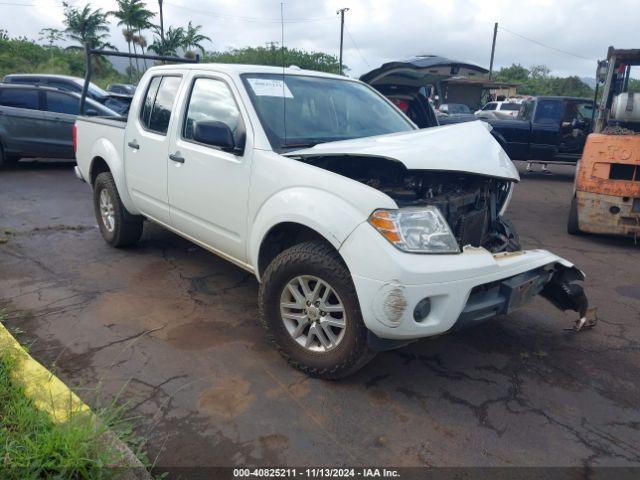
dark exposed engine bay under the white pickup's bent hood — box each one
[299,155,520,253]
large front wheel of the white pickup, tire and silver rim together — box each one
[259,242,373,379]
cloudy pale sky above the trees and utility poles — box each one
[0,0,640,77]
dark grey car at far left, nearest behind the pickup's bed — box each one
[0,84,118,166]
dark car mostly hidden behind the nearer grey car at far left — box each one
[3,74,131,114]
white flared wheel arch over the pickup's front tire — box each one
[249,187,371,275]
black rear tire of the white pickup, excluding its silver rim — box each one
[93,172,143,247]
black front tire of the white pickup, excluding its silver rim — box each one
[259,241,375,380]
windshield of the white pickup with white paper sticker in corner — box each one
[242,74,415,150]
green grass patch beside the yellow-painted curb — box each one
[0,338,147,480]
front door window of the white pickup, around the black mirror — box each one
[182,78,244,145]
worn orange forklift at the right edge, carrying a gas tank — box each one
[567,47,640,240]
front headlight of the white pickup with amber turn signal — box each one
[369,206,460,253]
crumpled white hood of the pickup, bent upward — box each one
[286,121,520,182]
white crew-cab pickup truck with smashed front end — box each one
[74,64,586,378]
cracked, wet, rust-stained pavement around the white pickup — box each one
[0,159,640,474]
